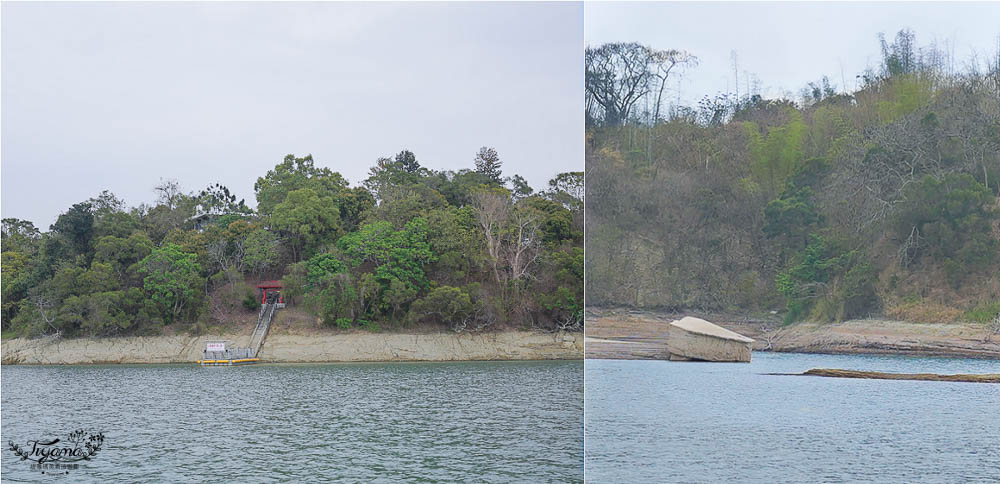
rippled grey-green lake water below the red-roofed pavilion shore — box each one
[2,361,583,482]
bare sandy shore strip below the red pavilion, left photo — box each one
[0,331,583,365]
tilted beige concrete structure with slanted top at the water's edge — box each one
[667,317,753,363]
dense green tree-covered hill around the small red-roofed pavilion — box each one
[2,147,583,339]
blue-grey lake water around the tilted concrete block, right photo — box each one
[585,353,1000,483]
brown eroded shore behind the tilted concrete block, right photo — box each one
[586,310,1000,359]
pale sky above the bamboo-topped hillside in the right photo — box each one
[584,2,1000,105]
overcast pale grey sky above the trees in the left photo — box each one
[2,2,584,230]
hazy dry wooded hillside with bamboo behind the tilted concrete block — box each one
[586,30,1000,334]
